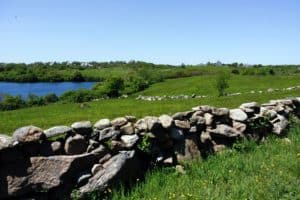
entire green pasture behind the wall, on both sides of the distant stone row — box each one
[0,75,300,135]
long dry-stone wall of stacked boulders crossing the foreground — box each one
[0,98,300,199]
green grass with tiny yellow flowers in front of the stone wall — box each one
[108,126,300,200]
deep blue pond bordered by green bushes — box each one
[0,82,95,98]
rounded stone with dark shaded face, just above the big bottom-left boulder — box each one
[65,134,87,155]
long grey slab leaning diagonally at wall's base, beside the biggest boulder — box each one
[79,151,139,197]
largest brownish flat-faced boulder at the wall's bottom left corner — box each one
[0,154,97,199]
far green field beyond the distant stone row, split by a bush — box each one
[139,75,300,96]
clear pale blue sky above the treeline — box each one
[0,0,300,64]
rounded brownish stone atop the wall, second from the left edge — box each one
[13,126,45,143]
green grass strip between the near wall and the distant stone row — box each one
[0,90,300,134]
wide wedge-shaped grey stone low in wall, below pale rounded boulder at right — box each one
[209,124,242,138]
